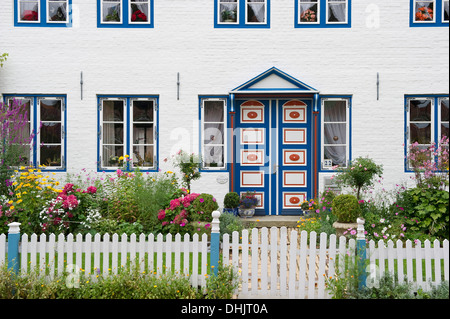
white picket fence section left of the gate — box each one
[0,234,209,286]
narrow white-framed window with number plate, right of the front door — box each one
[321,98,350,169]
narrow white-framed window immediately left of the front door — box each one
[200,98,227,170]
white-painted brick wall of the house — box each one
[0,0,449,205]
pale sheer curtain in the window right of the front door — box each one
[324,101,347,166]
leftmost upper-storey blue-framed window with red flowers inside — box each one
[14,0,72,28]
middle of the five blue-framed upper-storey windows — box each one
[214,0,270,28]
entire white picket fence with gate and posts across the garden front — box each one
[0,218,449,299]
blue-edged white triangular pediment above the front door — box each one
[230,67,319,94]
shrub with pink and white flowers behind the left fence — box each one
[39,183,101,234]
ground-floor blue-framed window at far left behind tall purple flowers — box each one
[4,94,67,171]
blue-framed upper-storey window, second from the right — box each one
[294,0,352,28]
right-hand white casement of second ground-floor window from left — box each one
[130,98,157,169]
